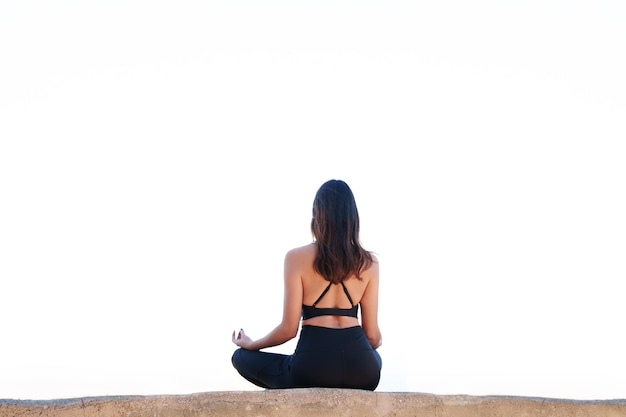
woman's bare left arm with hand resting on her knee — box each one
[232,250,303,350]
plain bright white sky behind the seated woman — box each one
[0,0,626,399]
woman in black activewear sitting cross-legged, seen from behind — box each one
[232,180,382,391]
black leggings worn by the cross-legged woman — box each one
[232,326,382,391]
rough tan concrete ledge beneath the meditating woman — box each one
[0,388,626,417]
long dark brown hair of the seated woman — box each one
[311,180,374,284]
